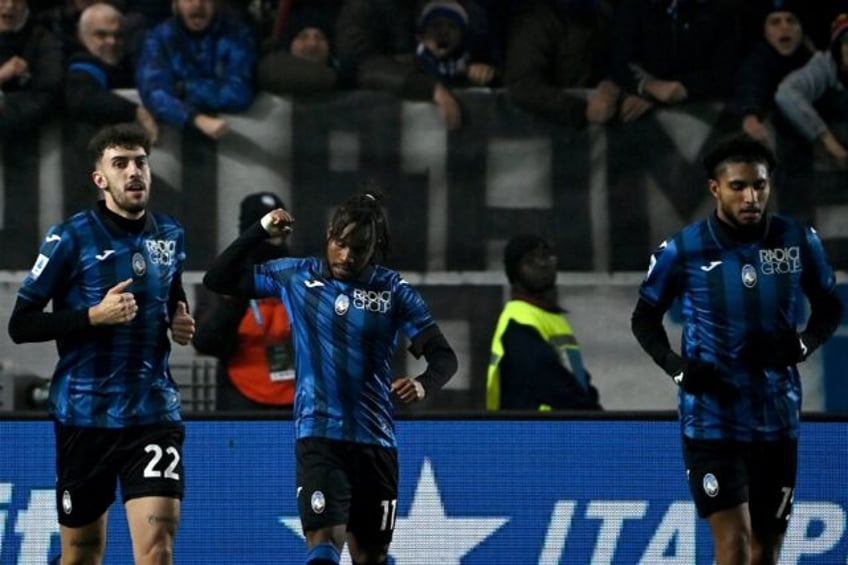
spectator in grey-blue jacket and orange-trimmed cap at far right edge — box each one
[775,13,848,168]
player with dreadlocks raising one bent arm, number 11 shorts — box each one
[203,187,457,565]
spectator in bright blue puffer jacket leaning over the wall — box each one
[136,0,257,139]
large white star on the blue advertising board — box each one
[280,459,509,565]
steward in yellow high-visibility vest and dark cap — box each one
[486,234,601,410]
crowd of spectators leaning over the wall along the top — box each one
[0,0,848,149]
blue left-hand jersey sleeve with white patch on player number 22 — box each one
[18,225,76,307]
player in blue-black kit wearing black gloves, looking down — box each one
[632,135,842,565]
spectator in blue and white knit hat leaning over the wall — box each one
[415,0,495,86]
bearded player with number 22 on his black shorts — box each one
[9,124,194,564]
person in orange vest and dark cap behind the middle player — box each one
[193,192,295,410]
